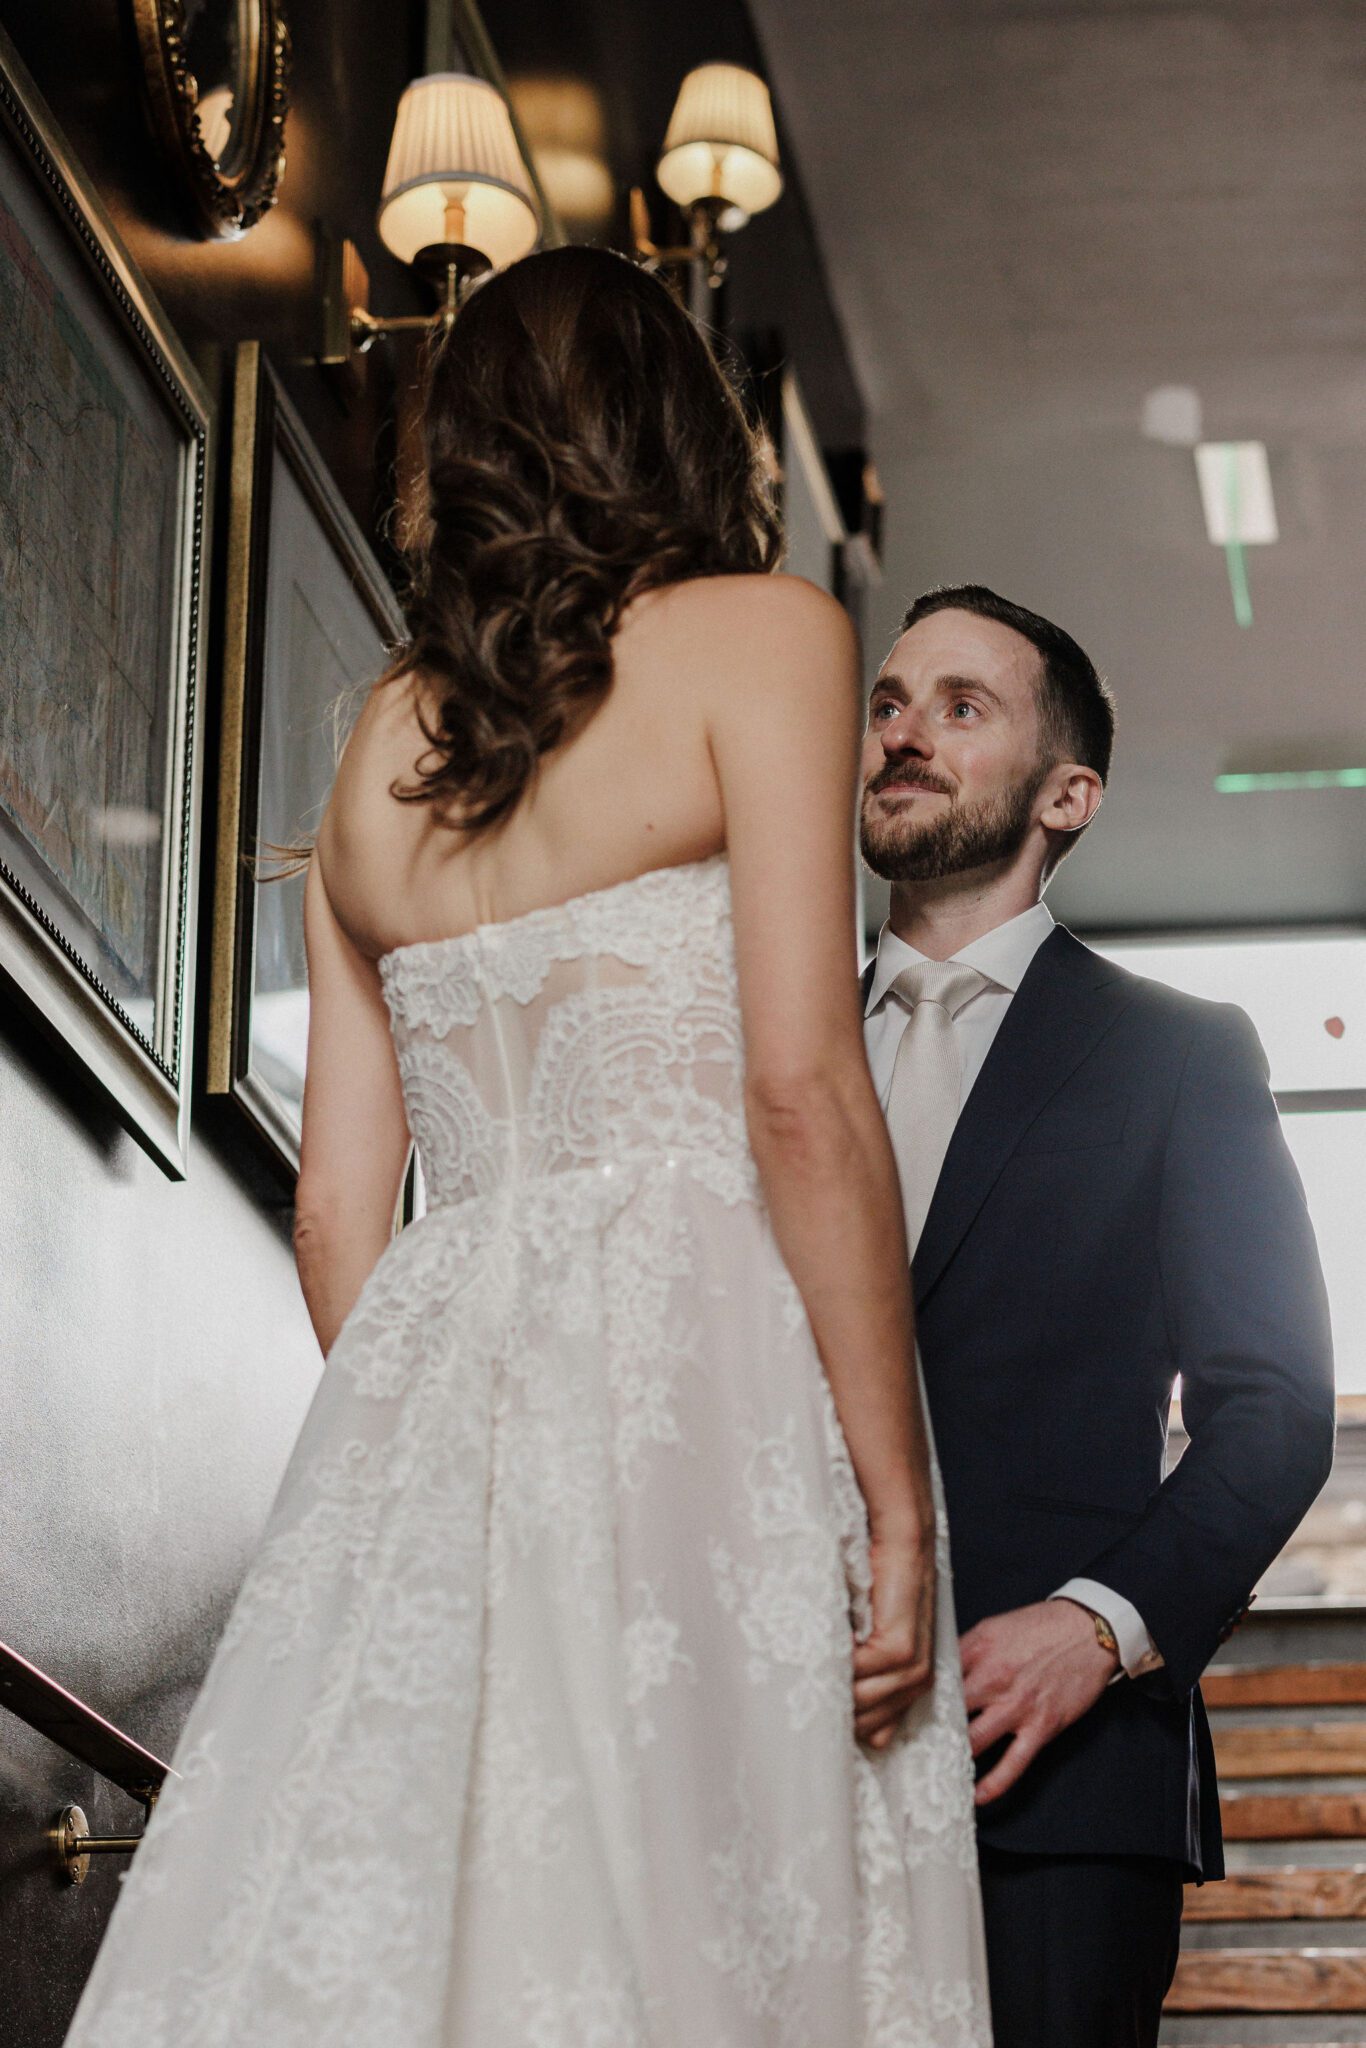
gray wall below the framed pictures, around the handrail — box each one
[0,1014,319,2048]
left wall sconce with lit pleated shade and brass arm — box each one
[329,72,541,362]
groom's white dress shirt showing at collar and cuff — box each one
[864,903,1161,1677]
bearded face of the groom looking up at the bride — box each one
[860,610,1047,881]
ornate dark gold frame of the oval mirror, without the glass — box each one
[131,0,289,240]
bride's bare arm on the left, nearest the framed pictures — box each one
[295,856,410,1352]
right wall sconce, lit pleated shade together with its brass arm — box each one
[631,63,782,291]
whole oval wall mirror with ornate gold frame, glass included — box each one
[131,0,289,236]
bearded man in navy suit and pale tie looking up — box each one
[862,586,1333,2048]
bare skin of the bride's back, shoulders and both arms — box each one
[295,575,934,1743]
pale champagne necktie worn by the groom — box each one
[887,961,991,1257]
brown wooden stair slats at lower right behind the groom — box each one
[1161,1663,1366,2048]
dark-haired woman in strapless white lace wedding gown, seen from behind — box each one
[70,248,989,2048]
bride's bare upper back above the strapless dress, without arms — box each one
[317,575,770,956]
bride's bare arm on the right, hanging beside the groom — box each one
[709,578,934,1739]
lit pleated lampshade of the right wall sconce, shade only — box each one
[655,63,782,213]
